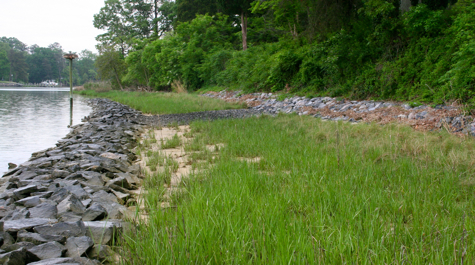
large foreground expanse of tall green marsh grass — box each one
[123,115,475,264]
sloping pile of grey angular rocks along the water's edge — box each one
[0,99,143,265]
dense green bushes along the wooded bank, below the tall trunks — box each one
[116,0,475,103]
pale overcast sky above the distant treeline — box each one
[0,0,104,53]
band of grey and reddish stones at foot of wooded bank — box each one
[203,91,475,136]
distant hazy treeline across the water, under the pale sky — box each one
[0,37,98,85]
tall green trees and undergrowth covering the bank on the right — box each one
[94,0,475,103]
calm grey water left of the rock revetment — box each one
[0,88,91,173]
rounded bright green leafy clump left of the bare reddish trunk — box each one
[139,14,236,90]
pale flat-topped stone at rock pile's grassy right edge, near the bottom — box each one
[84,220,122,245]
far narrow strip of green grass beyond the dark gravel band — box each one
[75,90,246,114]
